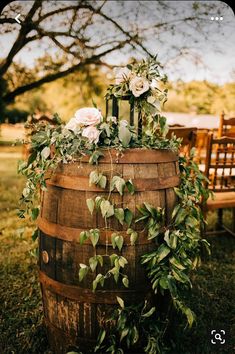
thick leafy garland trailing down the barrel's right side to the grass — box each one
[90,150,210,354]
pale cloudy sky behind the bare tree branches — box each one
[0,1,235,84]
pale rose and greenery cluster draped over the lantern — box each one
[106,58,168,141]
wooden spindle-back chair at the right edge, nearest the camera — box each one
[204,133,235,236]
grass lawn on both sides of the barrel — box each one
[0,147,235,354]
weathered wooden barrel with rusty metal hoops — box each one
[38,149,180,354]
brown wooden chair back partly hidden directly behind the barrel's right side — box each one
[167,126,197,155]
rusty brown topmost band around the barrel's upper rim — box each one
[79,148,179,164]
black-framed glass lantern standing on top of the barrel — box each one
[106,95,142,137]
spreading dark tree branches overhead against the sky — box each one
[0,0,232,120]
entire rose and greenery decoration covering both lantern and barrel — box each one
[19,58,208,354]
